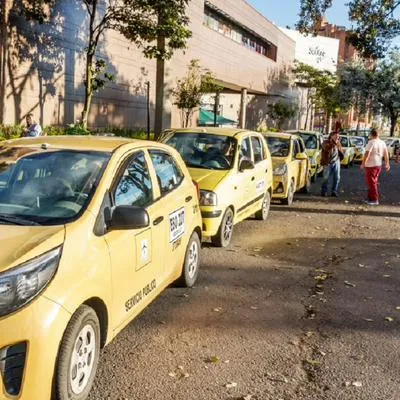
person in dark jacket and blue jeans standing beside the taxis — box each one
[321,132,343,197]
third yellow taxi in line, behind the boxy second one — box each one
[264,133,311,206]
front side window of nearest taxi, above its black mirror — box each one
[114,152,153,207]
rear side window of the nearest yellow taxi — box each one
[149,150,184,195]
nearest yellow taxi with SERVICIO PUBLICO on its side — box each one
[0,136,201,400]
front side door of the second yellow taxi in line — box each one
[233,136,256,220]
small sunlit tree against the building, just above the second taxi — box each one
[173,60,221,128]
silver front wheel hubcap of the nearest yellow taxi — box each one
[70,325,96,395]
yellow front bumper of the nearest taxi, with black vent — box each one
[0,295,71,400]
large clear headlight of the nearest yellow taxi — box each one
[0,246,62,317]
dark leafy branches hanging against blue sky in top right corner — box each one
[297,0,400,58]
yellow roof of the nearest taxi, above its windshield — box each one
[0,135,149,152]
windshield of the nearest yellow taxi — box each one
[0,147,110,225]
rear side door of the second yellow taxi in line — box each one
[251,135,268,206]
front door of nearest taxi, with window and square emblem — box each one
[105,151,167,328]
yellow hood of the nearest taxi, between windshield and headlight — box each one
[0,225,65,272]
